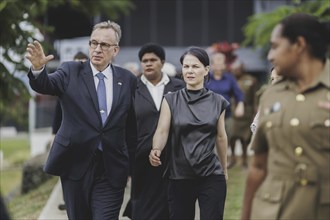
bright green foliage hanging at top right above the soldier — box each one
[242,0,330,50]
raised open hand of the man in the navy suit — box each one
[25,41,54,70]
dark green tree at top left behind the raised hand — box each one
[0,0,134,130]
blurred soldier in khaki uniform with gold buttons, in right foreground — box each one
[242,13,330,220]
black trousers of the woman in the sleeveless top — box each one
[168,175,227,220]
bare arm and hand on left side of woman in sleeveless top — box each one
[149,99,171,167]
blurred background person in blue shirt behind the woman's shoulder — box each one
[206,52,244,167]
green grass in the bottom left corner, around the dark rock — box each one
[0,135,58,220]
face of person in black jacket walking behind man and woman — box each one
[141,53,164,81]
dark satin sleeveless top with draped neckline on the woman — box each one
[165,88,229,179]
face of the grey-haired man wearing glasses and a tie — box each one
[89,29,119,71]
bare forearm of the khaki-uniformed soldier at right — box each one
[241,152,268,220]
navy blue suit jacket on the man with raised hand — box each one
[28,61,137,187]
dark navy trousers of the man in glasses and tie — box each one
[61,150,125,220]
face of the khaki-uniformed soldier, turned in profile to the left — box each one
[267,25,299,77]
